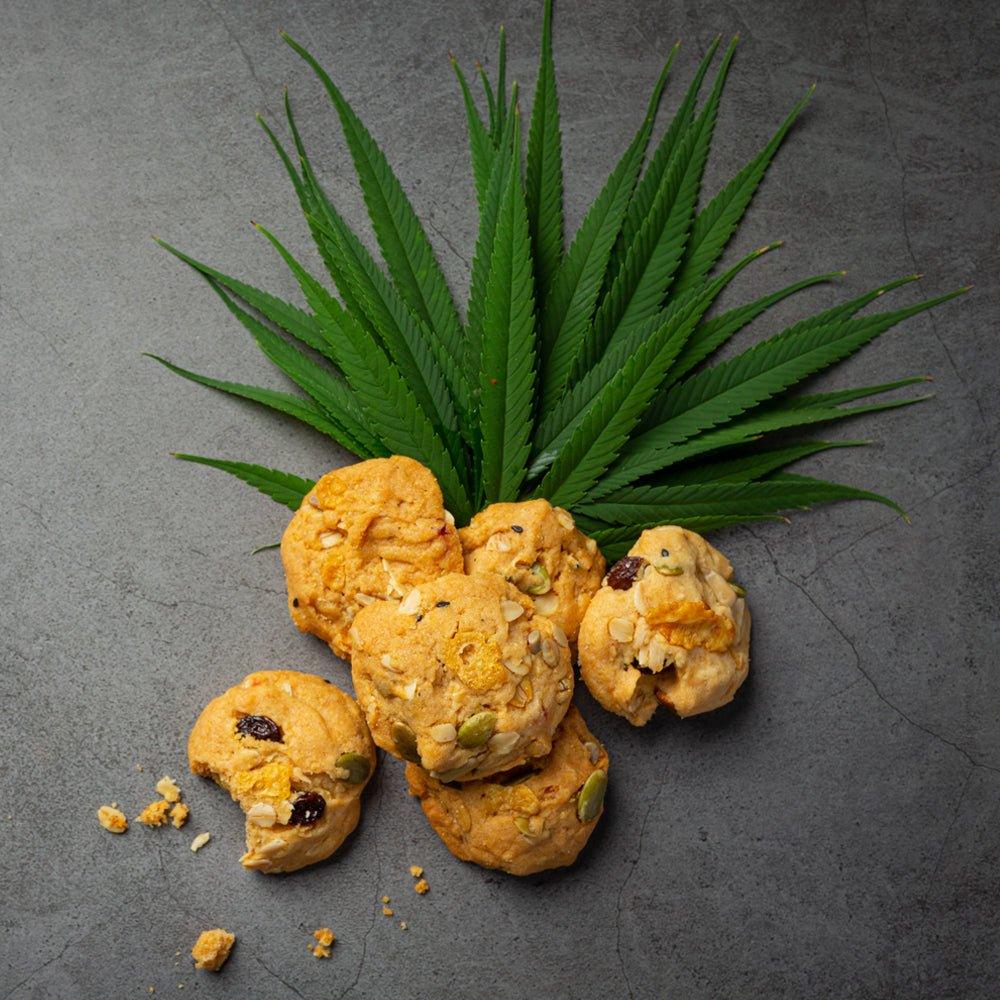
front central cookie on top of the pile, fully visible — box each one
[351,573,573,781]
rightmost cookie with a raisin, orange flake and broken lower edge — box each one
[579,527,750,726]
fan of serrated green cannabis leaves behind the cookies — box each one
[149,0,967,558]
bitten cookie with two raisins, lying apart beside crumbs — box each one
[188,670,375,872]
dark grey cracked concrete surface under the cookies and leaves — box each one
[0,0,1000,1000]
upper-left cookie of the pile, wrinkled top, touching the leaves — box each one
[281,455,462,659]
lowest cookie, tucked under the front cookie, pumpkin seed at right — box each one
[406,706,608,875]
